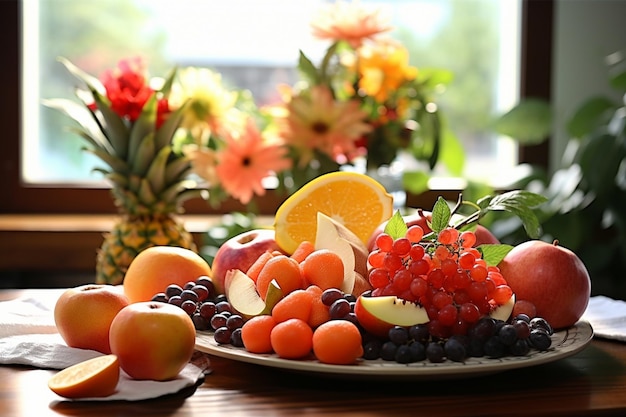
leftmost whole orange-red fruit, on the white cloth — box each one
[54,284,129,354]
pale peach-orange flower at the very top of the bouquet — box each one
[311,1,391,49]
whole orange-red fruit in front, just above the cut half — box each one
[109,301,196,381]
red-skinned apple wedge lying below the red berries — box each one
[354,295,429,337]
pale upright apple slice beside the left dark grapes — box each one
[224,269,283,318]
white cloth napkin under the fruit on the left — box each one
[0,290,208,401]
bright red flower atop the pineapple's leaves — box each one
[101,57,154,122]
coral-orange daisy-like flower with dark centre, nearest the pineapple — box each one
[215,118,291,204]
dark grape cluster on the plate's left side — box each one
[152,276,244,347]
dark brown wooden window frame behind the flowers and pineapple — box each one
[0,0,554,214]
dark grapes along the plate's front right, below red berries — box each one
[363,314,553,363]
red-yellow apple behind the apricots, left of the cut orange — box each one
[211,229,282,293]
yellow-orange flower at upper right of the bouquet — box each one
[358,41,417,103]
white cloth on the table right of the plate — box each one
[582,295,626,342]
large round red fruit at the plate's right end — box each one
[498,240,591,329]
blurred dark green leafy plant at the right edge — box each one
[492,50,626,297]
